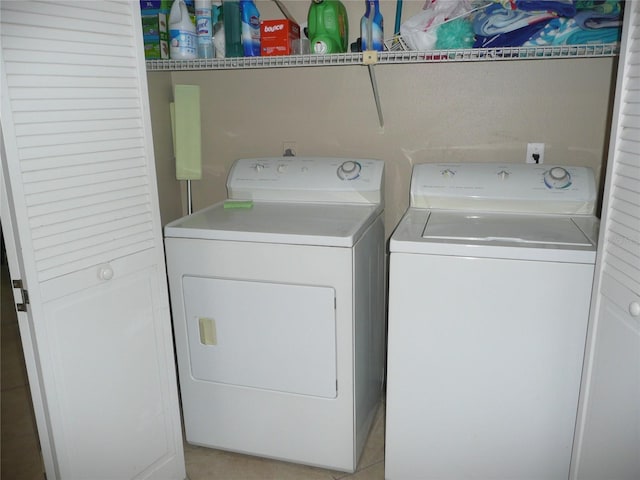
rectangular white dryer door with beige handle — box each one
[182,276,336,398]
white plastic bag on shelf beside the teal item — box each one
[400,0,474,50]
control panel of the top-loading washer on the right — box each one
[411,163,596,214]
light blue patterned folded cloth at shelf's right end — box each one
[524,17,620,47]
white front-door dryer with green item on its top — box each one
[165,157,386,471]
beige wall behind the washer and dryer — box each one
[148,2,616,235]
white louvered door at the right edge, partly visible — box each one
[571,1,640,480]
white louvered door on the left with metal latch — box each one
[0,0,185,480]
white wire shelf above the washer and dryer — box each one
[146,43,620,72]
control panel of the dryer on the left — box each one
[227,157,384,203]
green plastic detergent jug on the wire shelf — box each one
[307,0,349,53]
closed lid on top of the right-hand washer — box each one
[422,211,591,247]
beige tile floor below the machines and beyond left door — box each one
[0,258,384,480]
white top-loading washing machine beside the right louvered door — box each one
[385,164,598,480]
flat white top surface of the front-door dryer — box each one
[164,202,382,247]
